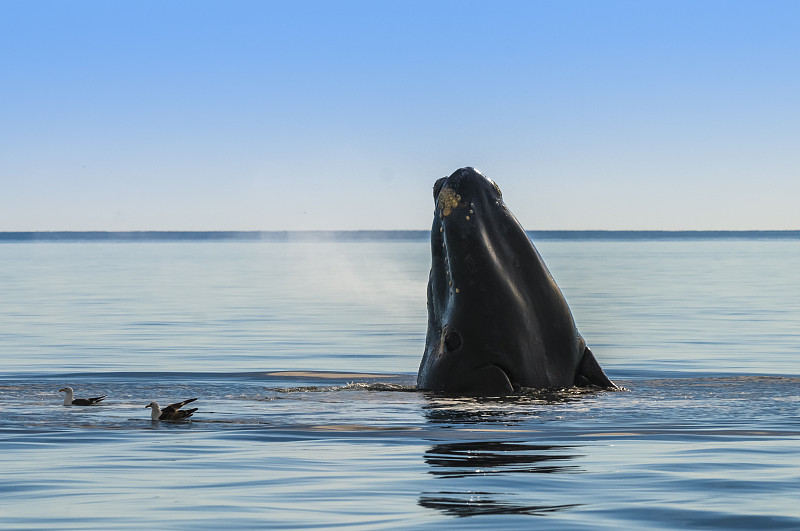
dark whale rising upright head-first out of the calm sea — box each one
[417,168,616,396]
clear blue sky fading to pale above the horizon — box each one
[0,0,800,231]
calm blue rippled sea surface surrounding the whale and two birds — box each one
[0,238,800,530]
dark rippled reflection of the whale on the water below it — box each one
[417,389,594,517]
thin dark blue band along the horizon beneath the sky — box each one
[0,230,800,243]
